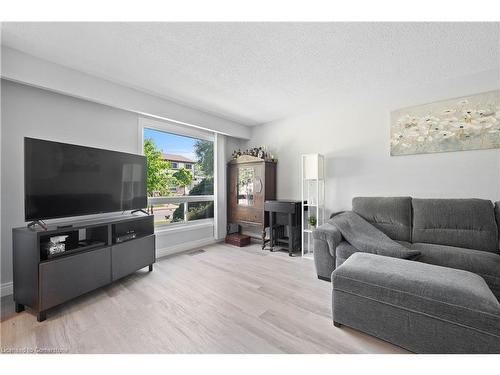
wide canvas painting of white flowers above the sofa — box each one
[391,90,500,156]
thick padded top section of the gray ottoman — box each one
[332,252,500,340]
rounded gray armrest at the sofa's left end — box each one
[312,223,342,281]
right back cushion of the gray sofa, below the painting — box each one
[412,198,498,253]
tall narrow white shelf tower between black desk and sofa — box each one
[301,154,325,259]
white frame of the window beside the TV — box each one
[138,116,218,231]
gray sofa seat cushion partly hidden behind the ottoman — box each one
[410,243,500,298]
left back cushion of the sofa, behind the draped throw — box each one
[352,197,411,242]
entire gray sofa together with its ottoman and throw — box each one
[313,197,500,353]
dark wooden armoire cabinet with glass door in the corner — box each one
[227,155,276,238]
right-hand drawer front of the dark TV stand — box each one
[111,235,155,280]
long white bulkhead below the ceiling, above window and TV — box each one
[1,46,250,138]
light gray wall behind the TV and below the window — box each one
[0,79,229,294]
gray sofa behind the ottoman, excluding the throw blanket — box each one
[313,197,500,300]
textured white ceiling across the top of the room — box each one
[2,23,500,125]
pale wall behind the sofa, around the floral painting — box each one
[248,70,500,216]
